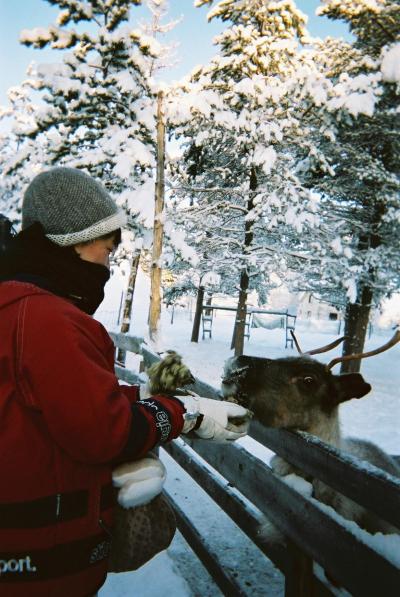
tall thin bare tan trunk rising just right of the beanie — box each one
[149,92,165,341]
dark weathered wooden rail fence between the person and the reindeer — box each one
[111,333,400,597]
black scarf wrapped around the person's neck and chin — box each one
[0,223,110,315]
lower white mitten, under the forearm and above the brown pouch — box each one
[112,455,167,508]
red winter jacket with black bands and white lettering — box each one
[0,281,184,597]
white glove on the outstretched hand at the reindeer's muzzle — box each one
[176,396,252,442]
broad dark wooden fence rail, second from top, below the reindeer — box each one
[179,440,400,597]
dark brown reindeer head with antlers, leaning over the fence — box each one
[222,332,400,432]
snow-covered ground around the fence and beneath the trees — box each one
[97,273,400,597]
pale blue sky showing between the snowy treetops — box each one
[0,0,348,104]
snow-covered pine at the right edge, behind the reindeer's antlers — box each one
[288,0,400,371]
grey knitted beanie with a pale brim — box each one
[22,168,126,246]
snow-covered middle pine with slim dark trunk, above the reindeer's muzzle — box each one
[169,0,315,354]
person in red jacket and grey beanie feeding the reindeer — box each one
[0,168,246,597]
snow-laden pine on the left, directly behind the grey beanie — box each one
[2,0,160,251]
